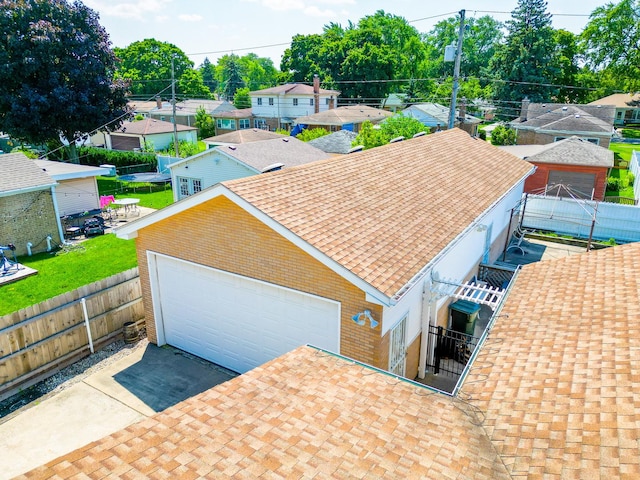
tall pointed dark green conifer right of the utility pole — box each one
[492,0,557,110]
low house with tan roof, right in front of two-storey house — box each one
[294,105,393,133]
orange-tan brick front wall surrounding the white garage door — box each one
[136,197,388,370]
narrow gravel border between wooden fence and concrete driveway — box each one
[0,329,149,424]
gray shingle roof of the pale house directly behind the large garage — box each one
[216,137,331,171]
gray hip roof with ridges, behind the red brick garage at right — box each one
[510,103,615,135]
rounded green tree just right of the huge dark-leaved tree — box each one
[114,38,193,98]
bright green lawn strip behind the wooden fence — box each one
[0,233,138,315]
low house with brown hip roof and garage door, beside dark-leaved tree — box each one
[106,118,198,151]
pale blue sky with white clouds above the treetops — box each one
[84,0,615,69]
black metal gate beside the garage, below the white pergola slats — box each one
[427,325,480,377]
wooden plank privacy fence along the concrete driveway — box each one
[0,268,144,400]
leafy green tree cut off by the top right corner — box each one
[581,0,640,92]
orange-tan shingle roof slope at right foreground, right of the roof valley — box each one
[462,243,640,479]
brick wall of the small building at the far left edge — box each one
[0,190,61,256]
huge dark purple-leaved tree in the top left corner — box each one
[0,0,127,163]
